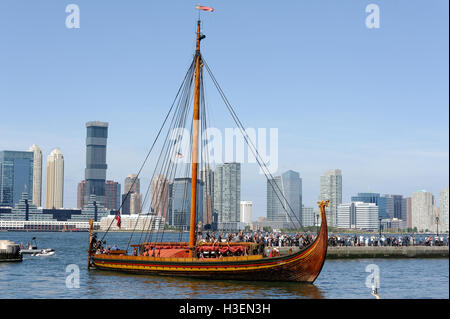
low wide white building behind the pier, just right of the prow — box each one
[337,202,379,231]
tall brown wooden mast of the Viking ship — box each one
[189,20,201,256]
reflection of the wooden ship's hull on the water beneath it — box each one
[88,270,324,299]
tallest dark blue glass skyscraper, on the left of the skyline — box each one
[84,121,108,206]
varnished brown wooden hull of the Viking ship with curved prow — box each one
[91,204,328,283]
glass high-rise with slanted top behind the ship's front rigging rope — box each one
[267,170,302,226]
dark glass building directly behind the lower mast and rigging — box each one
[168,177,203,230]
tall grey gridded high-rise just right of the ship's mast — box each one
[214,163,241,228]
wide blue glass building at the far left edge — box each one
[0,151,34,207]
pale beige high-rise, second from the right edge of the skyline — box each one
[411,190,435,231]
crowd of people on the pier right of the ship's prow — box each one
[328,234,448,247]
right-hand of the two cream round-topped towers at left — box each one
[45,149,64,209]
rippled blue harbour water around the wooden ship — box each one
[0,232,449,299]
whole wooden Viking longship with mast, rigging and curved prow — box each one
[88,10,328,283]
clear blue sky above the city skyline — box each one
[0,0,449,216]
